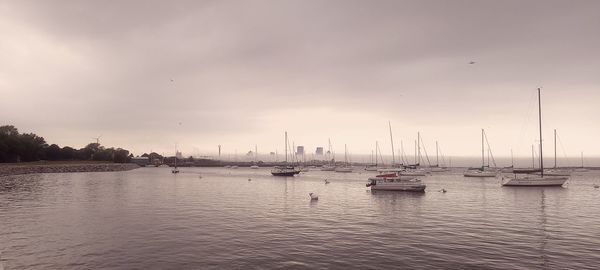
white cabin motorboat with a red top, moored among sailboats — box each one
[367,173,426,192]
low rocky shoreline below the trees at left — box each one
[0,163,139,177]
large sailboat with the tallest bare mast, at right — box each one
[502,88,569,186]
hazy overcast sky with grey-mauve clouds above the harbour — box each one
[0,0,600,159]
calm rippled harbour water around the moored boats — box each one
[0,168,600,270]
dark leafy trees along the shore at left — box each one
[0,125,133,163]
